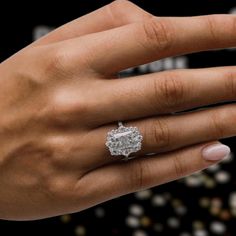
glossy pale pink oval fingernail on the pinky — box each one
[202,143,230,161]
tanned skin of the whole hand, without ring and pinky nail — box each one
[0,0,236,220]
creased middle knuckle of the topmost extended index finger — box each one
[141,16,174,51]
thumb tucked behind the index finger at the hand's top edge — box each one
[33,0,151,45]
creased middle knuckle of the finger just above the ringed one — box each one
[158,72,186,110]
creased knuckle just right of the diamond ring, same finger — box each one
[151,119,170,150]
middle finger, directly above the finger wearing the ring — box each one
[84,67,236,126]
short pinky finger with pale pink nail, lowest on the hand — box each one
[77,141,230,205]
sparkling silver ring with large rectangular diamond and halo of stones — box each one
[106,122,143,160]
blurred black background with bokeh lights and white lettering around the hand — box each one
[0,0,236,236]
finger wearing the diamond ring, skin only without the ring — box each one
[91,104,236,166]
